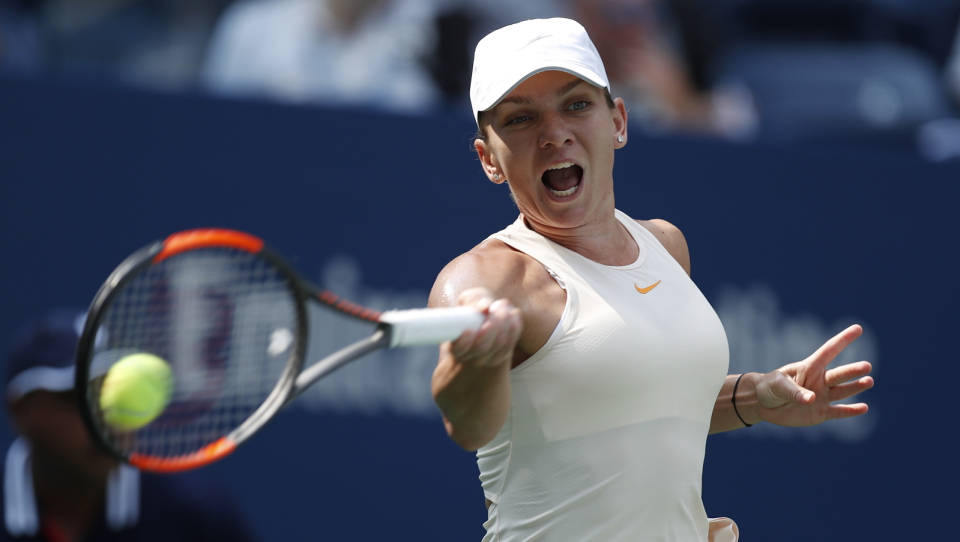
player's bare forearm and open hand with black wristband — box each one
[710,325,873,433]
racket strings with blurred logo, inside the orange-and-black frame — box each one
[89,248,299,458]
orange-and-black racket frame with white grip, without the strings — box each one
[75,229,484,472]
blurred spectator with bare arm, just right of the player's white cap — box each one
[573,0,755,138]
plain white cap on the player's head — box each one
[470,18,610,125]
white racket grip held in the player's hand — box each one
[380,307,483,348]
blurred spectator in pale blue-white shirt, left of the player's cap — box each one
[203,0,441,113]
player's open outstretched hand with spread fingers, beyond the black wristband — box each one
[752,325,873,427]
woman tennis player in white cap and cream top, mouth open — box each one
[430,19,873,542]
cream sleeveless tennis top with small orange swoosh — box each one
[477,211,737,542]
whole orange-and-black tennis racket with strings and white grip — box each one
[76,229,483,472]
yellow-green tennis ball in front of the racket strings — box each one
[100,353,173,429]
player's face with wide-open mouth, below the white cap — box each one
[476,71,627,235]
